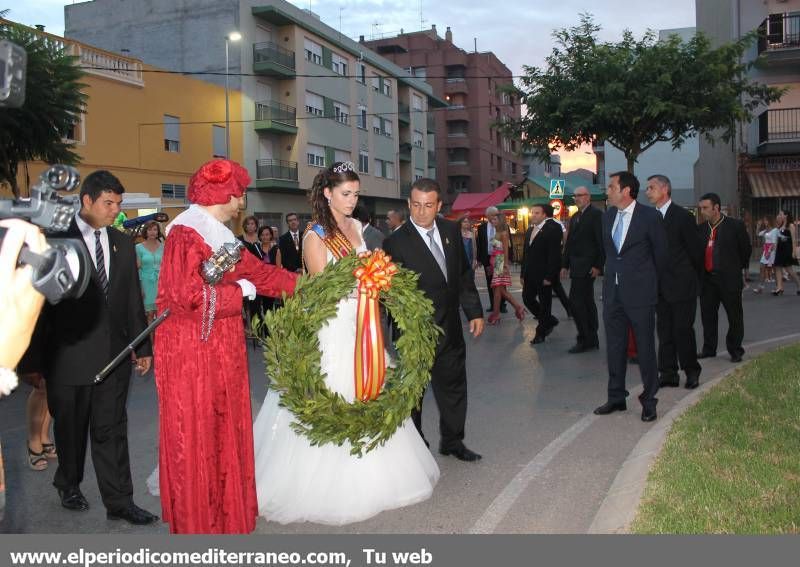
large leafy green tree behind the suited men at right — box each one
[501,14,783,172]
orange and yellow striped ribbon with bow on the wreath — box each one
[353,250,397,402]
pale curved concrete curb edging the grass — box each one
[587,365,743,534]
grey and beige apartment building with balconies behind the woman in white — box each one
[65,0,446,231]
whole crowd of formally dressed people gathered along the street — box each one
[0,155,800,533]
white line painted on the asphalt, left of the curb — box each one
[469,413,597,534]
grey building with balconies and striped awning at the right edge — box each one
[694,0,800,229]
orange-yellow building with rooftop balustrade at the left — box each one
[3,20,242,221]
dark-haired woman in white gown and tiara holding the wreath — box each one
[253,162,439,525]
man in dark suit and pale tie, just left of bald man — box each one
[520,205,562,345]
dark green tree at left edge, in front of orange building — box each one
[0,21,86,196]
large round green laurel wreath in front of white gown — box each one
[253,254,442,456]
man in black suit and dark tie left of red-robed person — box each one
[23,171,158,525]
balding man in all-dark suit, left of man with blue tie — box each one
[561,187,605,354]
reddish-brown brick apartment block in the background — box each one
[360,25,523,206]
